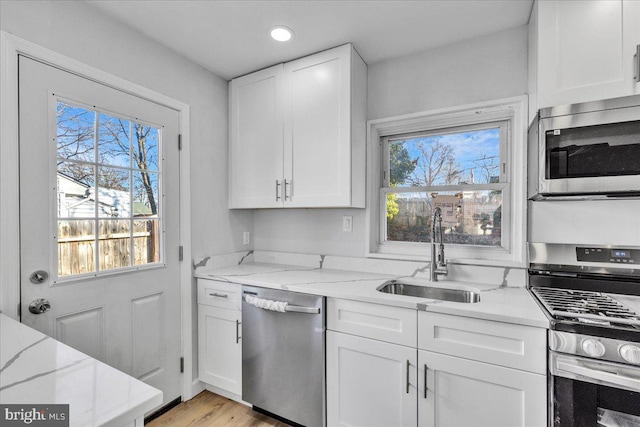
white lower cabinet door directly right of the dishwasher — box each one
[327,331,417,427]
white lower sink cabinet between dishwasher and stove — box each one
[326,298,547,427]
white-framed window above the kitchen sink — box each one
[369,100,526,264]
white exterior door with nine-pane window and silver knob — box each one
[19,57,181,410]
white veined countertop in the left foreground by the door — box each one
[0,314,162,427]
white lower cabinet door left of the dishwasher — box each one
[198,304,242,395]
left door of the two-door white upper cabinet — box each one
[229,64,283,208]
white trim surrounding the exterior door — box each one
[0,31,202,400]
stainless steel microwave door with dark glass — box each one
[538,106,640,196]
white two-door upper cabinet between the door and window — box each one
[229,44,366,208]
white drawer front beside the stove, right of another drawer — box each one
[418,311,547,374]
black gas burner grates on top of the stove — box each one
[532,287,640,327]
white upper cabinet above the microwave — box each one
[529,0,640,114]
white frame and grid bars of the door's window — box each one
[49,96,166,286]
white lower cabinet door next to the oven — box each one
[418,350,547,427]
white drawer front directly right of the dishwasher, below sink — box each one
[327,298,417,347]
